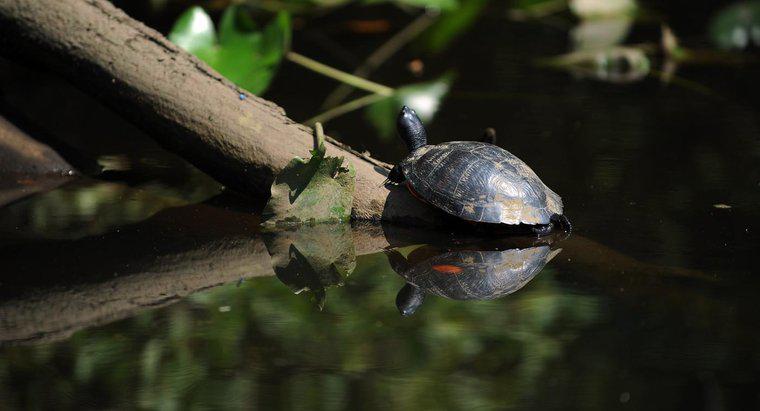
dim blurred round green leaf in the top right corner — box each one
[710,1,760,49]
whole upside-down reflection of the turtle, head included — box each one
[392,245,562,316]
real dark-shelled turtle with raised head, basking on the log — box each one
[386,106,572,235]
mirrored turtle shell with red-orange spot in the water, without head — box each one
[399,246,561,300]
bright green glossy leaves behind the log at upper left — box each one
[169,6,291,94]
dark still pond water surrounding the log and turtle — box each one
[0,2,760,410]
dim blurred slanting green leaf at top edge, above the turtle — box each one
[420,0,488,53]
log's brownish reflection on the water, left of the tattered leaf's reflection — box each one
[0,206,273,344]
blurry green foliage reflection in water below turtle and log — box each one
[0,255,598,409]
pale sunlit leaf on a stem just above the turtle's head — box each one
[365,73,454,139]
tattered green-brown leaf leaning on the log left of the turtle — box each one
[262,124,356,226]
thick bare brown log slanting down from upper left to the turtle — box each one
[0,0,443,225]
